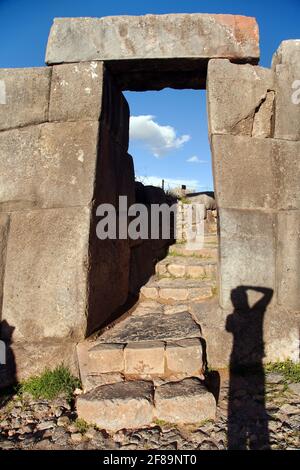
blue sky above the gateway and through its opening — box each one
[0,0,300,190]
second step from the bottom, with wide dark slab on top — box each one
[77,302,205,391]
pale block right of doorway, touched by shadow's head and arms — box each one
[219,209,276,308]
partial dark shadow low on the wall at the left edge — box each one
[0,320,17,400]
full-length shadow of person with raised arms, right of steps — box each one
[226,286,273,450]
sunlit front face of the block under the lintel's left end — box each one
[49,62,104,121]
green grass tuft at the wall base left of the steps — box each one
[18,364,80,400]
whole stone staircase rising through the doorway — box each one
[77,237,217,432]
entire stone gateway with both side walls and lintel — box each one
[0,14,300,385]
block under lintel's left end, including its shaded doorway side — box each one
[49,61,129,151]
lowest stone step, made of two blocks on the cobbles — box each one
[76,378,216,433]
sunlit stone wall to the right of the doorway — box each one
[207,41,300,360]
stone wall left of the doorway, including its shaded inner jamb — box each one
[0,62,135,382]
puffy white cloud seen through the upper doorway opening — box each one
[129,115,191,157]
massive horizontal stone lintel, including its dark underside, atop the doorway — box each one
[46,14,259,90]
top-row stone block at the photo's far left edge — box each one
[0,67,51,130]
